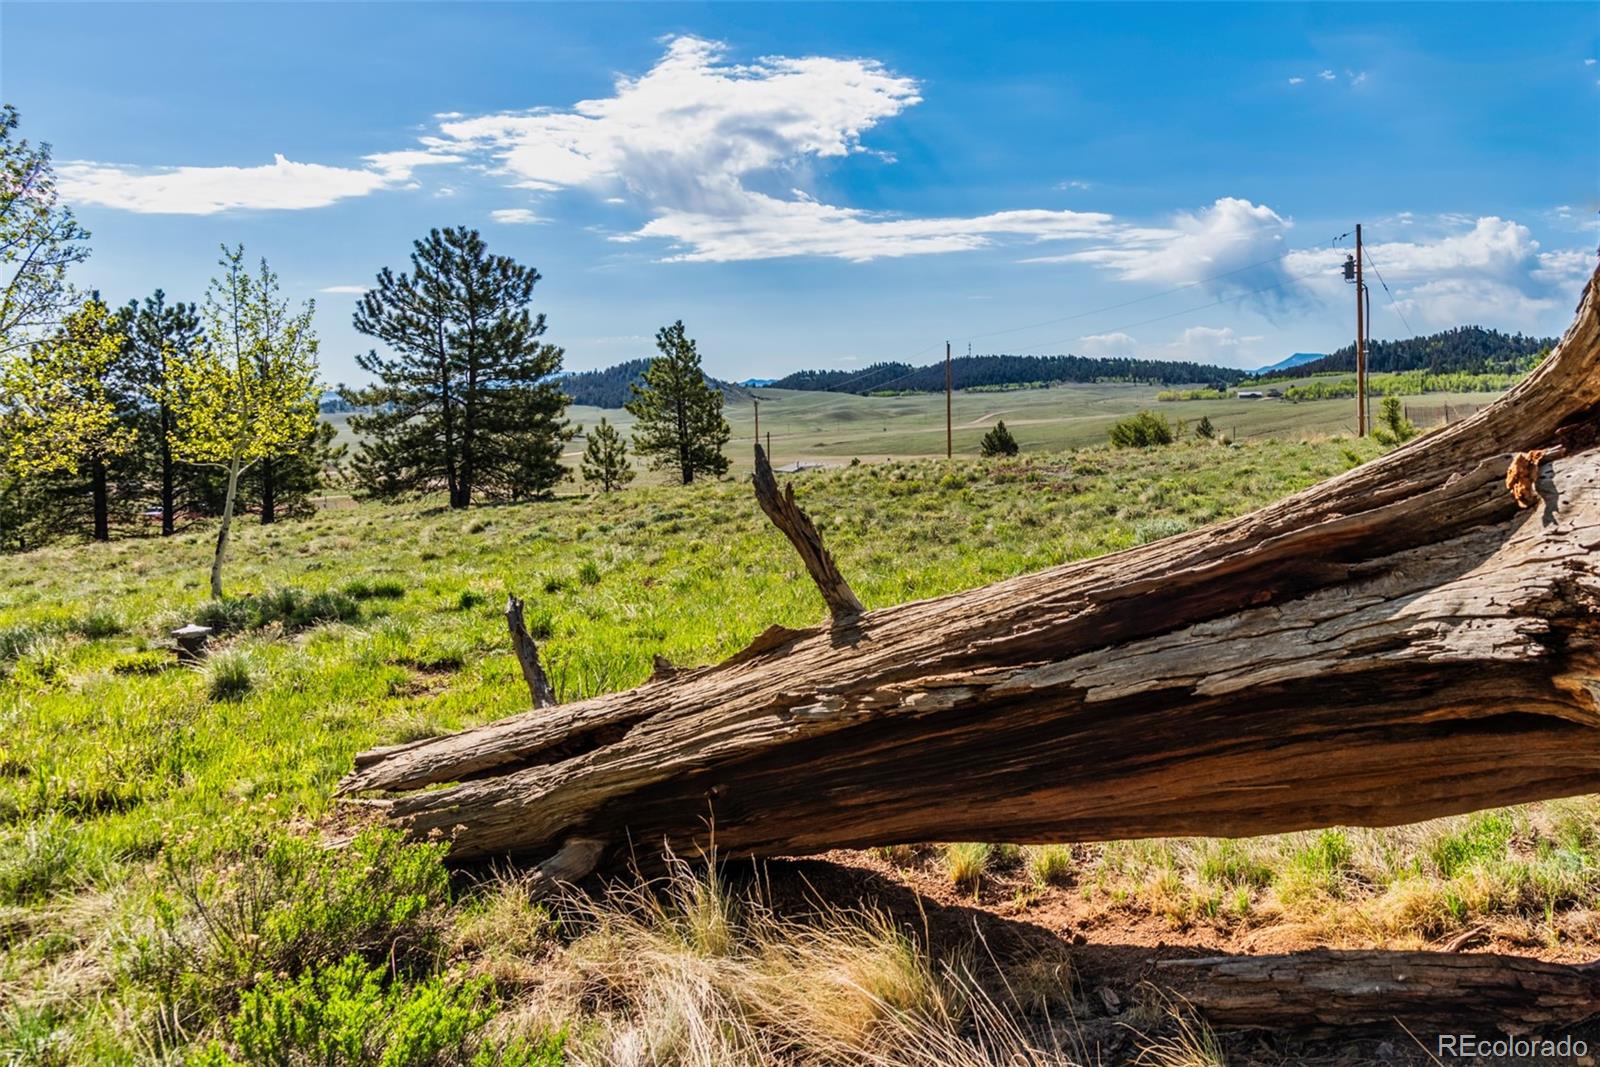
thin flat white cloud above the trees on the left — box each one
[59,150,461,214]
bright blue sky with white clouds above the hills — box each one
[0,3,1600,381]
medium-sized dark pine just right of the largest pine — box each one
[624,318,731,485]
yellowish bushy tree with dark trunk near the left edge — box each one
[0,299,134,541]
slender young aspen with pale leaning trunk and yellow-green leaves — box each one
[173,245,317,600]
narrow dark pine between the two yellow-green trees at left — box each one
[117,290,202,536]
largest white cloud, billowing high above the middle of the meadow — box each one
[425,37,1110,262]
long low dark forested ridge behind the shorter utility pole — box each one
[773,355,1245,394]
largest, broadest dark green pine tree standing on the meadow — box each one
[341,229,576,507]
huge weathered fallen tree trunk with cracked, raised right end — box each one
[342,273,1600,872]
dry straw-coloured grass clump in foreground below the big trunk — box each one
[480,861,1083,1067]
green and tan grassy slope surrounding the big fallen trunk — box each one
[0,438,1600,1064]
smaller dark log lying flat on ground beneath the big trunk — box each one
[1157,950,1600,1033]
